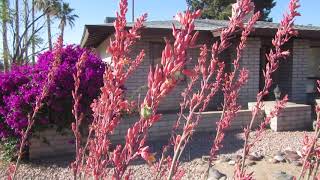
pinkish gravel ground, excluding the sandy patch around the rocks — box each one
[0,130,312,180]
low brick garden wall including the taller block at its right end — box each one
[29,102,312,159]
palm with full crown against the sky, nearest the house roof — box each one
[57,3,79,38]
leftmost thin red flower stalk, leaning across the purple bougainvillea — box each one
[8,37,63,180]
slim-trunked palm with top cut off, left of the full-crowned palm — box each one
[35,0,60,50]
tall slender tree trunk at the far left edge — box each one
[1,0,9,71]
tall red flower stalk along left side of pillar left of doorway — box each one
[209,1,260,162]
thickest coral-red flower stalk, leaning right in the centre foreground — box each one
[109,11,200,179]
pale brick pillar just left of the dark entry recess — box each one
[239,38,261,107]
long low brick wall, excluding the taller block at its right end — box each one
[29,110,263,159]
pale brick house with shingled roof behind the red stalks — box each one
[81,19,320,111]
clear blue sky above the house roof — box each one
[59,0,320,43]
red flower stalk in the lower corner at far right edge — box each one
[299,81,320,179]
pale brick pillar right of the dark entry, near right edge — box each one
[291,39,310,103]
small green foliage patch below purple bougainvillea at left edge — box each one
[1,136,19,162]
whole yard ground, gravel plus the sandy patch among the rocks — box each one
[0,130,313,180]
